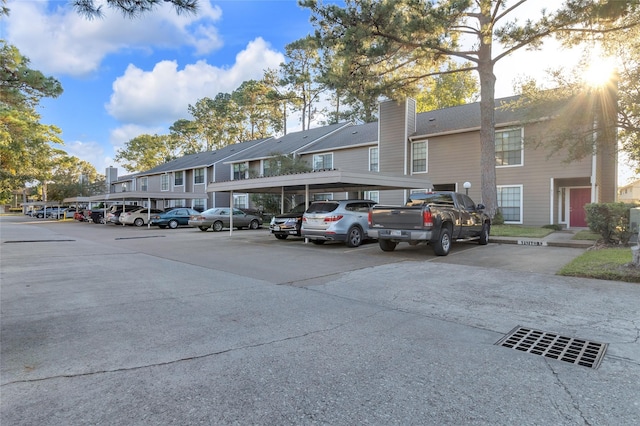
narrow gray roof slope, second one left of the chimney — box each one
[225,123,351,163]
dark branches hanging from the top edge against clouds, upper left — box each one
[71,0,198,19]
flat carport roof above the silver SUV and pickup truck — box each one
[207,170,433,194]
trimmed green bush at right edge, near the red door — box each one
[584,203,637,244]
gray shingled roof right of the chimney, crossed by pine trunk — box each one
[412,96,531,138]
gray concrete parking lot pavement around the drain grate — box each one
[0,217,640,425]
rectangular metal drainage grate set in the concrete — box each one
[496,326,607,369]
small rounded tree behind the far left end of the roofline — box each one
[114,135,180,172]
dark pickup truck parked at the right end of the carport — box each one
[368,191,491,256]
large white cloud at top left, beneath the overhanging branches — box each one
[3,0,222,76]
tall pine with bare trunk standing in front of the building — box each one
[300,0,638,216]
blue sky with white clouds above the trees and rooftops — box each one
[0,0,630,183]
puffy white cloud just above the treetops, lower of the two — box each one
[106,38,284,126]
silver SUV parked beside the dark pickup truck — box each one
[300,200,376,247]
